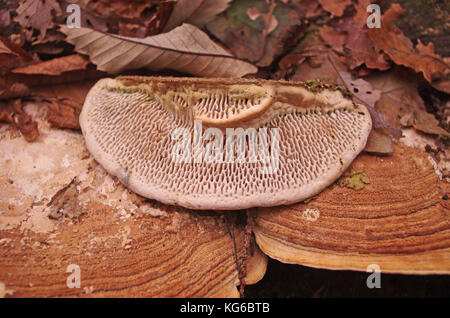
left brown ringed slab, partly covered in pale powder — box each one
[0,106,267,297]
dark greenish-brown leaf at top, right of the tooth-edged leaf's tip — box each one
[206,0,304,67]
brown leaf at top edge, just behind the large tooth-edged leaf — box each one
[163,0,231,32]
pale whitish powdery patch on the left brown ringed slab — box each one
[0,105,169,236]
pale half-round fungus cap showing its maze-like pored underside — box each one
[80,76,371,210]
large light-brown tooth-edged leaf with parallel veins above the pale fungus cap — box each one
[61,23,257,77]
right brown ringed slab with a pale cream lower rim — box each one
[251,144,450,274]
